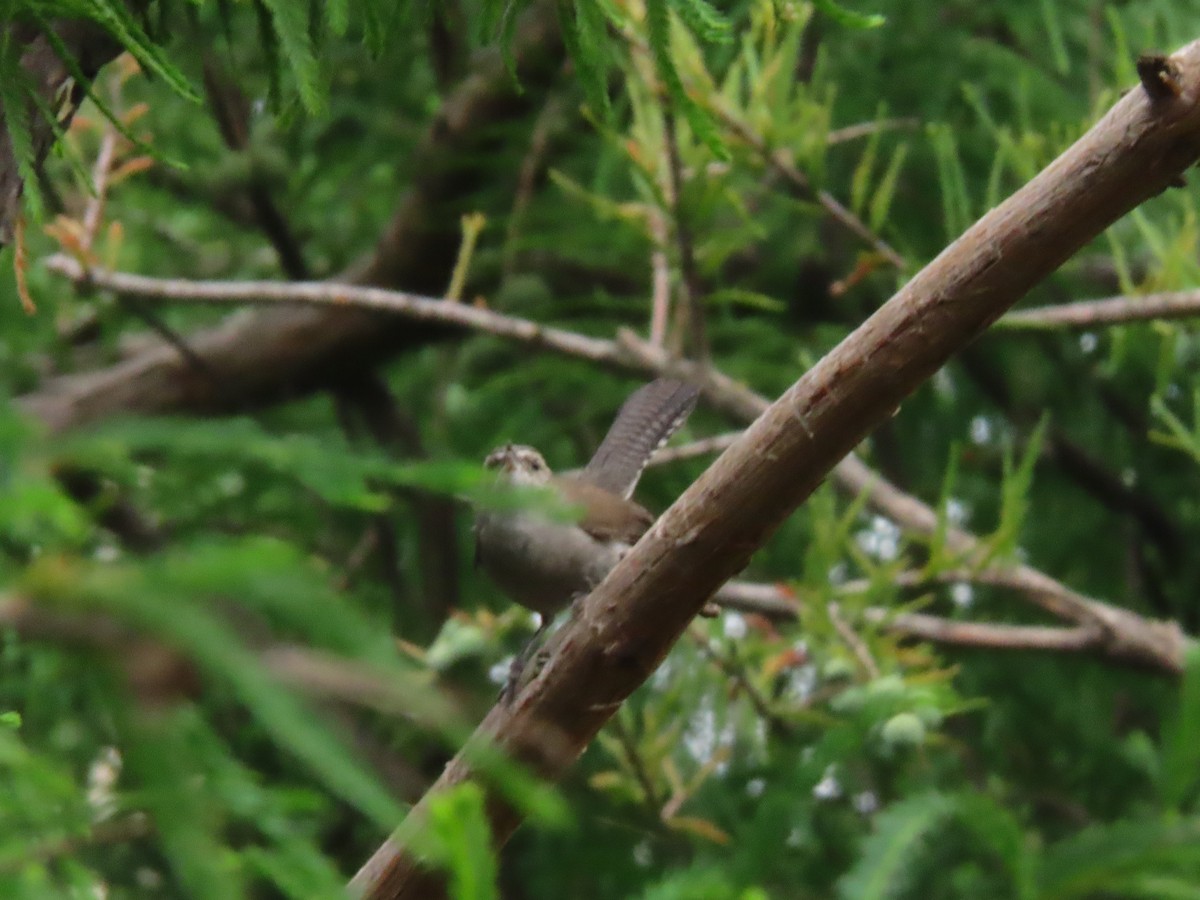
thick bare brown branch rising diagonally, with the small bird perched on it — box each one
[352,42,1200,898]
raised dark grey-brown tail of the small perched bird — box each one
[578,378,700,499]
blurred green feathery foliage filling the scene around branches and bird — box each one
[7,0,1200,898]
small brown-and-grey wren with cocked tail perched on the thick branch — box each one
[475,378,698,686]
